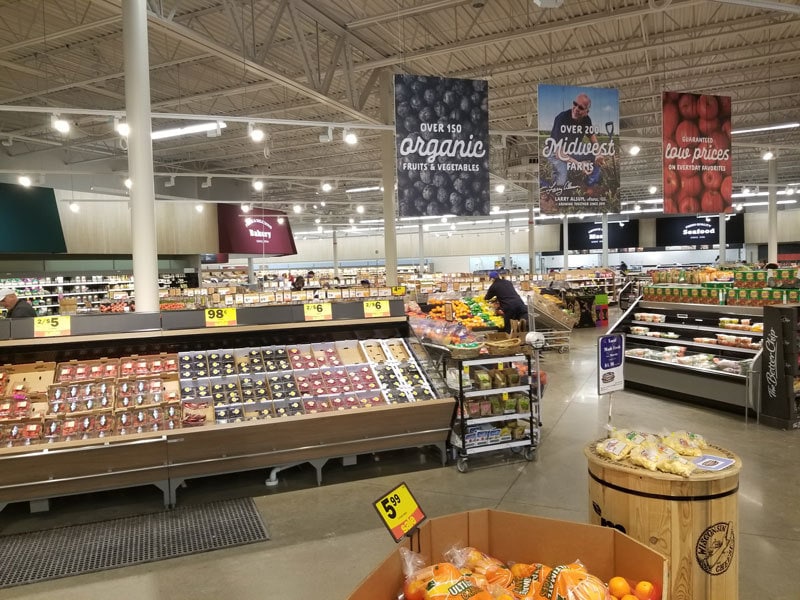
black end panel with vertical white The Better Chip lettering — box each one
[759,304,800,429]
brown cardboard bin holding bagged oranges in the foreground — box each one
[349,509,669,600]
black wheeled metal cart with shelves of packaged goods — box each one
[446,350,544,473]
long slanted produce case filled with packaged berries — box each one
[0,300,455,509]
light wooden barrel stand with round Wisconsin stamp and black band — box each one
[584,442,742,600]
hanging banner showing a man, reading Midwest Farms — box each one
[539,85,620,214]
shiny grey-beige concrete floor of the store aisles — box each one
[0,329,800,600]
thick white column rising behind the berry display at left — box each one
[122,1,158,312]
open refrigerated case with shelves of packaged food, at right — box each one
[609,300,763,411]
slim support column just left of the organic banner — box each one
[380,69,397,286]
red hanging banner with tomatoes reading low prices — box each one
[661,92,733,214]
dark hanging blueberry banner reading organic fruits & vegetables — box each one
[394,75,489,217]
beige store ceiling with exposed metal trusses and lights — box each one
[0,0,800,232]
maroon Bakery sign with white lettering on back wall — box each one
[217,204,297,256]
